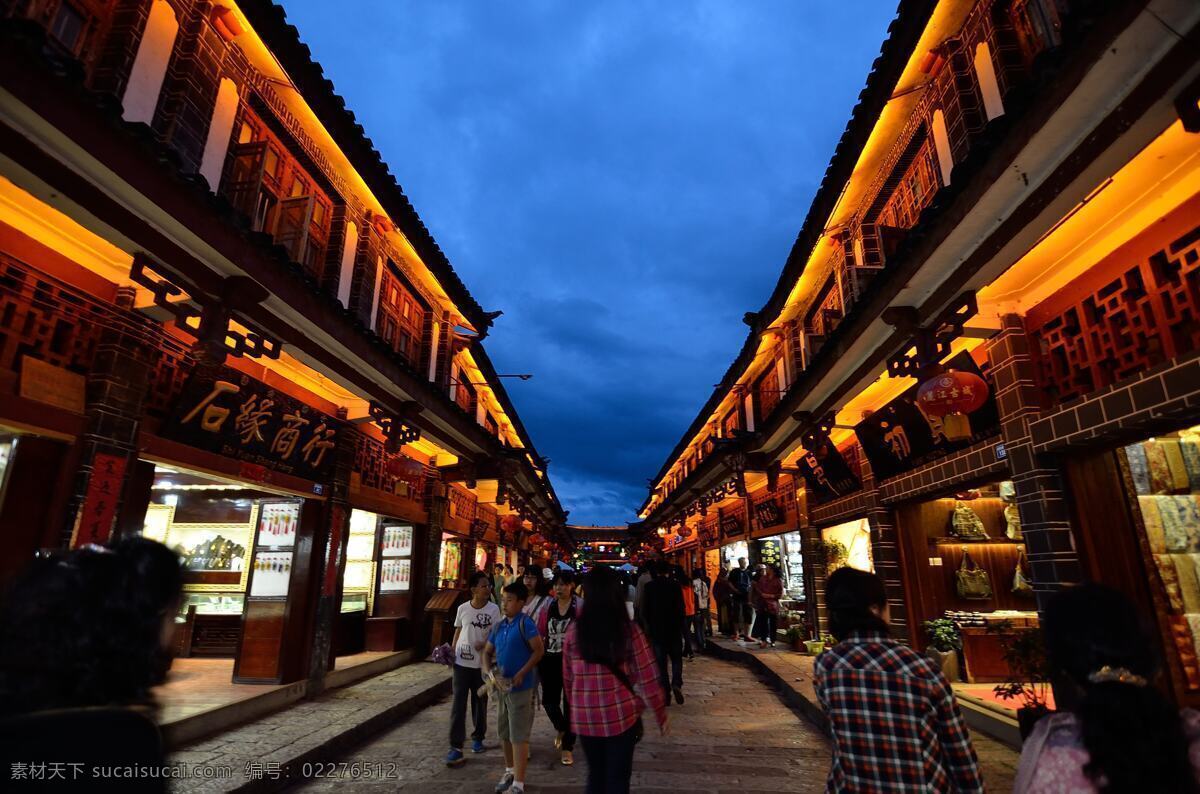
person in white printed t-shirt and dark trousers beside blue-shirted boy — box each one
[446,571,500,766]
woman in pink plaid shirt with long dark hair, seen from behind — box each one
[563,565,670,794]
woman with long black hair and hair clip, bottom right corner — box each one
[1014,584,1200,794]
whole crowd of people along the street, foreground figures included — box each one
[0,539,1200,794]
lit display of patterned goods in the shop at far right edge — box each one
[1123,426,1200,690]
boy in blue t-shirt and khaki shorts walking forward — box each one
[484,582,545,794]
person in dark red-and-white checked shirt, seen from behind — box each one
[814,569,983,793]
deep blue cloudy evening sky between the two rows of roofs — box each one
[284,0,895,524]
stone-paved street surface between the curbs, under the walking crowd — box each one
[293,657,829,794]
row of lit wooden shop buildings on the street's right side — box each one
[641,0,1200,705]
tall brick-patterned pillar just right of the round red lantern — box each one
[988,314,1084,608]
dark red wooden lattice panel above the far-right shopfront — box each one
[1027,221,1200,403]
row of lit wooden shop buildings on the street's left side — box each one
[0,0,565,687]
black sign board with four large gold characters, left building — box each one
[161,367,342,481]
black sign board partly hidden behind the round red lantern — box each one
[854,353,1000,480]
